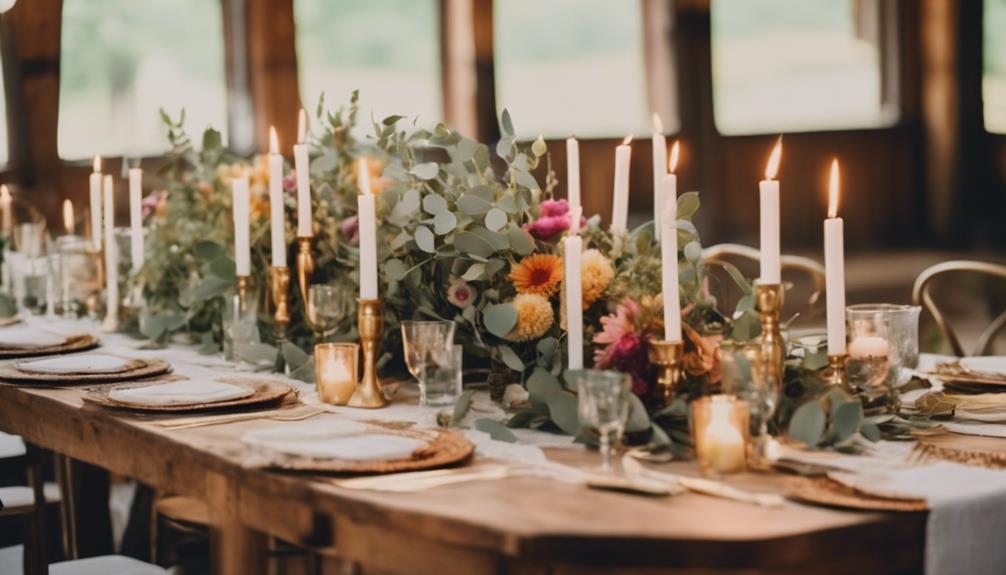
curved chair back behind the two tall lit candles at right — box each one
[702,243,825,324]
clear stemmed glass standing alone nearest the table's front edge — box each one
[576,369,632,473]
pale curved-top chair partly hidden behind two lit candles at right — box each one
[702,243,825,321]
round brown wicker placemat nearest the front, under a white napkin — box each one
[251,428,475,474]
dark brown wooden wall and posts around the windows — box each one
[0,0,1006,250]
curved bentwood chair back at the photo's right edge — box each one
[911,259,1006,357]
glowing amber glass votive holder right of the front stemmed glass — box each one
[691,394,749,476]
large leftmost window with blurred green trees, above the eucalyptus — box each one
[58,0,227,160]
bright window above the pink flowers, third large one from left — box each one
[493,0,651,138]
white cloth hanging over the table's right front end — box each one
[829,461,1006,575]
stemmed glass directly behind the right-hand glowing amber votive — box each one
[719,342,779,443]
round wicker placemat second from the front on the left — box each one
[83,377,296,413]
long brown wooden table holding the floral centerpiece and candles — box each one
[0,384,926,575]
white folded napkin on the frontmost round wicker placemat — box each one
[241,418,427,461]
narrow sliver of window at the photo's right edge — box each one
[982,0,1006,134]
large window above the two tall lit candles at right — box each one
[711,0,892,135]
